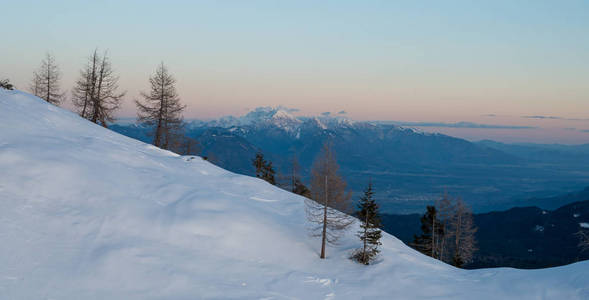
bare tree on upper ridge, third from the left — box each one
[135,62,186,149]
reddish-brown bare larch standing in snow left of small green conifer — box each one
[305,143,353,259]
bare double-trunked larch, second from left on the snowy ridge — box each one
[72,50,125,127]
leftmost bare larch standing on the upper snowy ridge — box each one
[29,53,65,105]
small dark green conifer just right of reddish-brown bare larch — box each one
[353,182,382,265]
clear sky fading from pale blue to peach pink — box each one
[0,0,589,143]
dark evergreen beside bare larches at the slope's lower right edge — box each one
[413,205,445,258]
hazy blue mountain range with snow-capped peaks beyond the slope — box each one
[111,107,589,213]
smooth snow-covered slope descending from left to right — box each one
[0,90,589,300]
